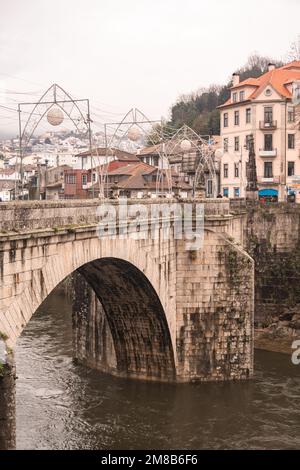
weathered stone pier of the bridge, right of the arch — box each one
[176,231,254,381]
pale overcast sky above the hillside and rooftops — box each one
[0,0,300,136]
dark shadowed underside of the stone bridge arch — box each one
[73,257,176,380]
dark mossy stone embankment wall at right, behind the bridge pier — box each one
[245,203,300,334]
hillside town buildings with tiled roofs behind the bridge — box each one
[0,60,300,203]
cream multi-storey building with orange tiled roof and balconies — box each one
[219,61,300,202]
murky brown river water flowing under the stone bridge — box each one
[16,291,300,449]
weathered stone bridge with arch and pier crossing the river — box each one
[0,199,254,448]
